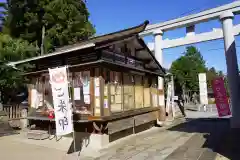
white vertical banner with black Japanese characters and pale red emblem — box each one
[49,66,73,136]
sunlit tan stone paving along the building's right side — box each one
[96,118,193,160]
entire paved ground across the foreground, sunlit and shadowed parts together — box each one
[0,111,240,160]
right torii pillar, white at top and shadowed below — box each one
[220,11,240,128]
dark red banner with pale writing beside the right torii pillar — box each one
[212,77,231,117]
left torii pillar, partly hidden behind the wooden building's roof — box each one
[154,30,166,123]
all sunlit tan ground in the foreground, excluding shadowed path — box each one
[0,117,192,160]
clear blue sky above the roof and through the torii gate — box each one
[87,0,240,72]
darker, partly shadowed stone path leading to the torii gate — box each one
[166,118,228,160]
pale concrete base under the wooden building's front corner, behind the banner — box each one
[14,132,109,157]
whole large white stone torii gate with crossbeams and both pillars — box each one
[140,1,240,128]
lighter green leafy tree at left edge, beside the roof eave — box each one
[0,34,38,103]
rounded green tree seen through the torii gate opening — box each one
[170,46,207,92]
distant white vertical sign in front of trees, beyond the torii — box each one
[198,73,208,104]
